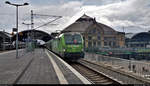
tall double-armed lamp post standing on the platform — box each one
[5,1,29,59]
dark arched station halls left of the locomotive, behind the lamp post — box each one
[0,30,52,50]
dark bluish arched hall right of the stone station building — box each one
[126,32,150,48]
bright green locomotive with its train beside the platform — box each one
[46,32,84,61]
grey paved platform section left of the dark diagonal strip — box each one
[0,50,33,84]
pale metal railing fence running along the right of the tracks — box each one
[85,53,150,79]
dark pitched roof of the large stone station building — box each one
[62,14,117,35]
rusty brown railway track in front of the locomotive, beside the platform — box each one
[70,60,120,84]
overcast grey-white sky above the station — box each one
[0,0,150,33]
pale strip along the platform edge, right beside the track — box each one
[49,51,92,84]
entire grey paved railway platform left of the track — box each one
[0,49,91,84]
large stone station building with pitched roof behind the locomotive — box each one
[62,14,125,48]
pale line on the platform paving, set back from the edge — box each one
[45,51,68,84]
